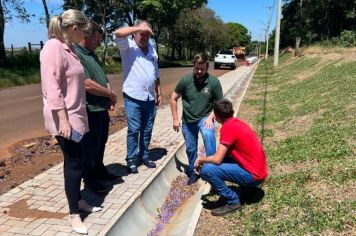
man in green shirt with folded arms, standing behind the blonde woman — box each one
[75,22,119,192]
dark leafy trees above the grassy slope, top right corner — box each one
[281,0,356,47]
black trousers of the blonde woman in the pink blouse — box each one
[56,136,84,214]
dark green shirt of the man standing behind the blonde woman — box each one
[74,44,109,112]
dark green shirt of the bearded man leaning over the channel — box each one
[175,74,223,123]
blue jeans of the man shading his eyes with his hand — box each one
[124,94,156,164]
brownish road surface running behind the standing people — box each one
[0,65,228,160]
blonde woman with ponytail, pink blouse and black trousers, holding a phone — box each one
[40,9,101,234]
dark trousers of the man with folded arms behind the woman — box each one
[83,111,110,184]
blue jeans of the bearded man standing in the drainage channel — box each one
[182,116,216,176]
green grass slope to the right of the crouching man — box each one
[220,52,356,235]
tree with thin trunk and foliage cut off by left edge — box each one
[0,0,30,67]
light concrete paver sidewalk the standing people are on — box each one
[0,65,256,235]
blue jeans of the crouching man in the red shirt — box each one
[200,157,261,204]
